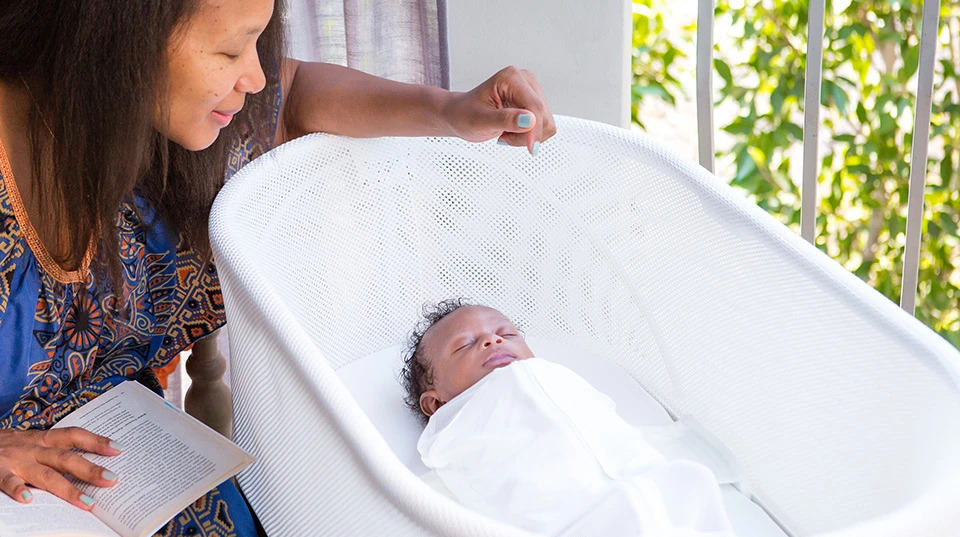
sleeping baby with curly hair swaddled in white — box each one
[401,300,734,537]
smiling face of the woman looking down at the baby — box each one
[154,0,274,151]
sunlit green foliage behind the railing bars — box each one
[632,0,960,347]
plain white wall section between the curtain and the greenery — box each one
[447,0,632,127]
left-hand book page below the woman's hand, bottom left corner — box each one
[0,489,119,537]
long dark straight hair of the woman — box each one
[0,0,283,283]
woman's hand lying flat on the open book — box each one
[0,427,120,510]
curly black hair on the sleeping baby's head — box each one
[400,298,474,425]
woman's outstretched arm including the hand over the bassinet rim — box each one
[276,59,557,150]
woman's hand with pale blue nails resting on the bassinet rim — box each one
[446,67,557,155]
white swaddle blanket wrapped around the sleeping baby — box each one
[417,358,734,537]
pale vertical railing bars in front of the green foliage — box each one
[697,0,940,314]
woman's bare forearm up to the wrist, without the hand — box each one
[280,60,454,140]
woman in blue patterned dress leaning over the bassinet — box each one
[0,0,555,536]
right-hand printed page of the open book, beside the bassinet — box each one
[56,382,253,537]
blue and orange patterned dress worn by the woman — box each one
[0,87,280,537]
